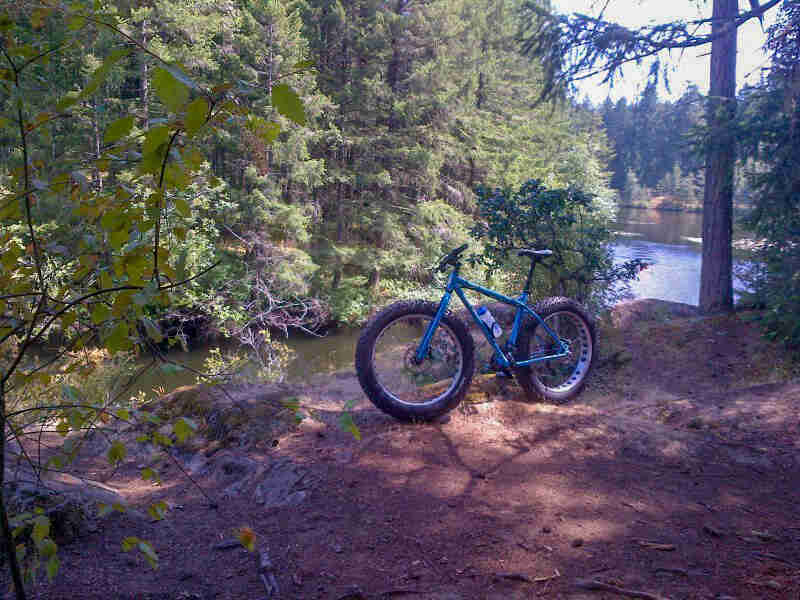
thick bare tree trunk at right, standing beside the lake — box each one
[700,0,738,313]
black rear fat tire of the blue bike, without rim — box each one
[514,296,597,404]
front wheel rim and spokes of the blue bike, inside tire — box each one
[372,314,464,406]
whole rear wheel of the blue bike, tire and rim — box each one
[515,297,596,402]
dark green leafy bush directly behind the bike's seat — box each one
[472,179,645,307]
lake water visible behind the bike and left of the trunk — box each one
[136,209,732,391]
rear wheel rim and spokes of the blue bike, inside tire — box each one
[530,311,593,396]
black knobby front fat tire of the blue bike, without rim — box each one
[355,301,475,421]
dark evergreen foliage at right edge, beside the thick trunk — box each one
[738,3,800,352]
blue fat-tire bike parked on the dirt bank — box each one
[355,245,595,421]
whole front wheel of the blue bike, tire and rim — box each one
[355,301,475,421]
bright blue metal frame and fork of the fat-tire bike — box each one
[416,266,569,368]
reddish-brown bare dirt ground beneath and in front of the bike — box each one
[9,301,800,600]
